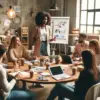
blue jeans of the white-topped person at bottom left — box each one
[7,90,36,100]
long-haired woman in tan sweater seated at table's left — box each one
[7,36,33,62]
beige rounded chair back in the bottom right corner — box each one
[85,83,100,100]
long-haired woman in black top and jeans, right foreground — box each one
[47,50,98,100]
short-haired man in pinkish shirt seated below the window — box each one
[72,34,89,58]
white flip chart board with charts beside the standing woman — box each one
[50,17,70,44]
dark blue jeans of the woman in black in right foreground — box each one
[47,83,74,100]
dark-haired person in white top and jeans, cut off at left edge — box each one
[0,45,35,100]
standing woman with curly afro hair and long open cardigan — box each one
[33,12,52,56]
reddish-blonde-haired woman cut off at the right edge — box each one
[89,39,100,66]
